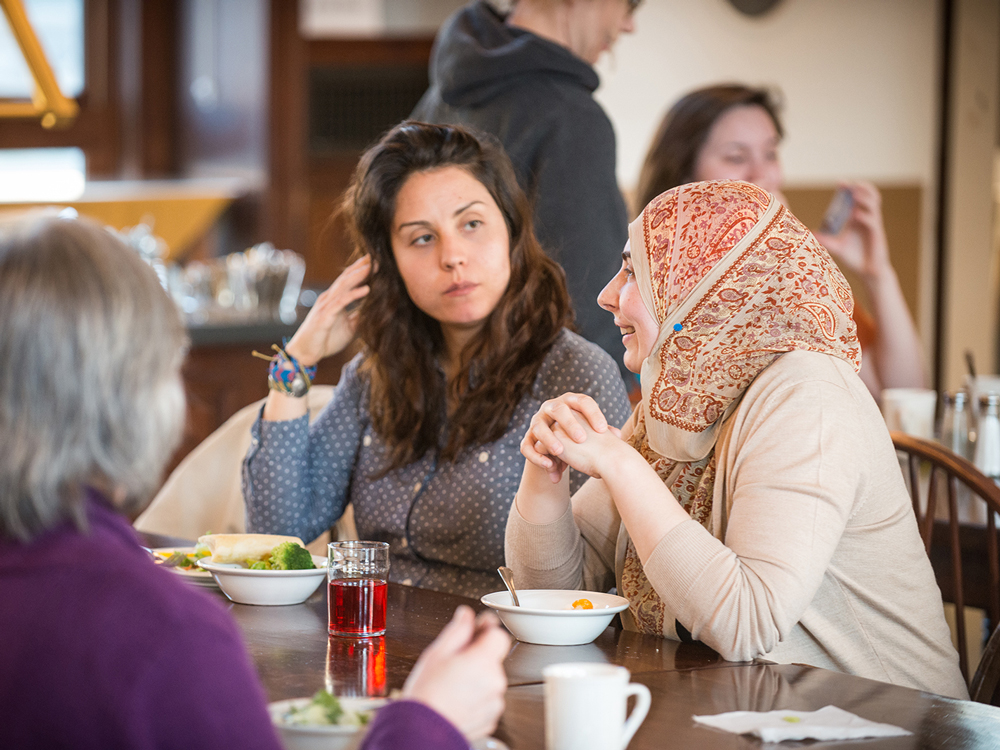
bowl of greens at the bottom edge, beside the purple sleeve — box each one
[267,690,387,750]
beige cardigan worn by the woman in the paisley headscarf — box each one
[506,351,968,698]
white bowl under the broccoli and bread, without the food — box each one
[198,555,326,606]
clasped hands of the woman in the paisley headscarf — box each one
[521,393,626,483]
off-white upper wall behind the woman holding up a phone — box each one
[597,0,939,187]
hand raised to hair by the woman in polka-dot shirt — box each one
[285,255,372,367]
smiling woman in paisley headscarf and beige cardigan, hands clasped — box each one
[506,181,967,697]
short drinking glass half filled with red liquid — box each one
[327,542,389,638]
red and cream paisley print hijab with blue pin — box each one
[622,181,861,635]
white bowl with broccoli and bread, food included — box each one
[198,534,326,606]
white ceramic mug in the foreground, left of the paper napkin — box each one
[542,662,650,750]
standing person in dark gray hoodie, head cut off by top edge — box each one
[410,0,639,384]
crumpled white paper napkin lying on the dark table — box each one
[694,706,913,742]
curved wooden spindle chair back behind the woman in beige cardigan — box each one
[891,432,1000,703]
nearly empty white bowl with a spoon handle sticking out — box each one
[481,589,628,646]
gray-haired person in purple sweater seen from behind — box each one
[0,217,510,750]
